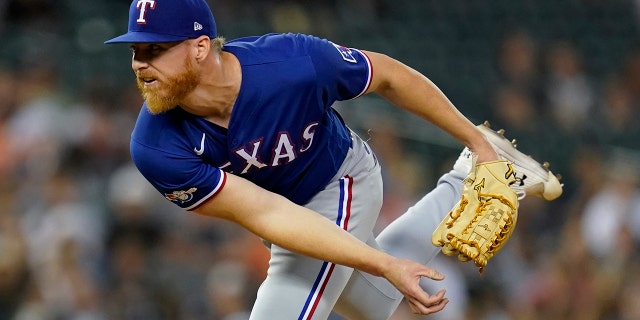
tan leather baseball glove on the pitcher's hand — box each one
[431,160,518,274]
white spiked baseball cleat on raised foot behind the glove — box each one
[454,121,562,201]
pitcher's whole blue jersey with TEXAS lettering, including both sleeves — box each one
[131,34,372,210]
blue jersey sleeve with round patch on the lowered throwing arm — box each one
[131,139,226,210]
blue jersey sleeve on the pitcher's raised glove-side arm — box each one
[306,36,373,101]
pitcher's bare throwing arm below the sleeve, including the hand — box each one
[192,174,448,314]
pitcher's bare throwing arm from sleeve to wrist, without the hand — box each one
[195,174,395,276]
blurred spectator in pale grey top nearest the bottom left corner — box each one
[22,170,105,319]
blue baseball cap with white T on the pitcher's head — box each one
[104,0,218,44]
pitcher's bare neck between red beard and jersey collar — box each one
[180,52,242,128]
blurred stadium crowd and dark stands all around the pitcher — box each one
[0,0,640,320]
